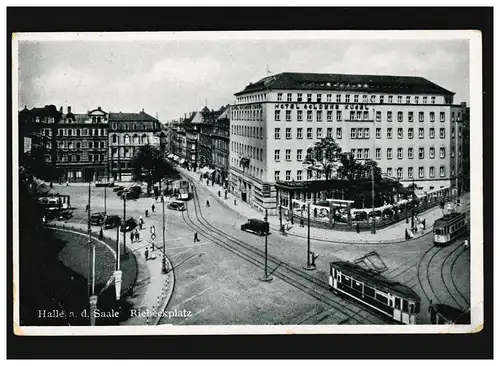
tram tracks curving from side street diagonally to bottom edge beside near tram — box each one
[177,179,387,324]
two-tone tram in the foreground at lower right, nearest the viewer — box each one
[329,261,420,324]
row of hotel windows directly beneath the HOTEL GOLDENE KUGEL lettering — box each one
[274,109,455,122]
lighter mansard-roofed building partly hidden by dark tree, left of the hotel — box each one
[109,110,161,181]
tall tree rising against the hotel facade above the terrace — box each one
[303,137,342,180]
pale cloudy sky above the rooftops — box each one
[18,39,469,122]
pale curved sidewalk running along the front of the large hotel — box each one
[177,167,470,244]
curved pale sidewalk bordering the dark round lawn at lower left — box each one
[50,223,175,325]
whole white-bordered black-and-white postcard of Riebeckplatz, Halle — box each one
[12,31,484,335]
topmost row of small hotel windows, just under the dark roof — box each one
[277,93,436,104]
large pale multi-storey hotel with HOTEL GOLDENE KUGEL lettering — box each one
[230,73,468,213]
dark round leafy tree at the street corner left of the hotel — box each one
[131,144,174,192]
